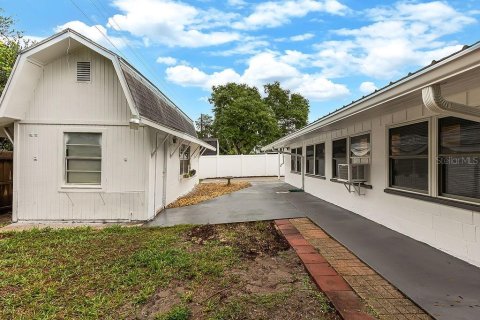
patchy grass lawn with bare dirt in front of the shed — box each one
[0,222,339,320]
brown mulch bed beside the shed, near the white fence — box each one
[167,181,251,208]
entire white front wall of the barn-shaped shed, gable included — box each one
[14,48,153,221]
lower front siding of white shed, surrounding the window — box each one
[16,124,150,220]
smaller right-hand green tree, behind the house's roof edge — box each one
[264,81,310,137]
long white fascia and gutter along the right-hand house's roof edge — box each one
[261,44,480,151]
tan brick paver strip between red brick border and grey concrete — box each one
[288,218,432,320]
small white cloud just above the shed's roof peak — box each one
[55,21,129,49]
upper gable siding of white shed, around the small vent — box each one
[24,48,131,123]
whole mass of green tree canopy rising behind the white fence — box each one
[205,82,309,154]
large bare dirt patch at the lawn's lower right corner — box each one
[141,249,341,320]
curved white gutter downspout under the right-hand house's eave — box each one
[422,84,480,117]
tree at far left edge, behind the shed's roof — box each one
[0,9,31,94]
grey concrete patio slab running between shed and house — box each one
[148,181,480,320]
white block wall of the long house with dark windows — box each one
[285,82,480,266]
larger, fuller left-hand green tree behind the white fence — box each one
[209,83,278,154]
